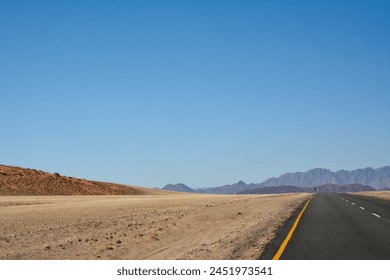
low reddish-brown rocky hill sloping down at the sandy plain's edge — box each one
[0,165,145,195]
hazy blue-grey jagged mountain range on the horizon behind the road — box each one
[163,166,390,194]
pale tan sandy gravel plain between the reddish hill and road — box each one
[0,194,309,260]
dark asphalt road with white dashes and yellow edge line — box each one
[268,193,390,260]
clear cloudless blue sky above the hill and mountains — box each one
[0,0,390,188]
